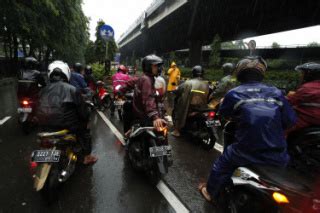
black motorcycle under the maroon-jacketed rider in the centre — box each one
[127,123,172,183]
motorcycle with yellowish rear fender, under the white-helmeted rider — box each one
[30,130,81,202]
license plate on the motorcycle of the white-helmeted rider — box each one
[32,150,61,163]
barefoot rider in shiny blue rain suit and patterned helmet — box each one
[199,56,296,201]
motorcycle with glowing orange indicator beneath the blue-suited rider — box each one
[218,122,320,212]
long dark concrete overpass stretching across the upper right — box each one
[118,0,320,64]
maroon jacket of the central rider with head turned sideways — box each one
[121,74,159,120]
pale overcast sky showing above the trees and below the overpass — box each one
[83,0,320,46]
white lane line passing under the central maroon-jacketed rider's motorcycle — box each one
[97,110,189,213]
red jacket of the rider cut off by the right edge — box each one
[288,80,320,130]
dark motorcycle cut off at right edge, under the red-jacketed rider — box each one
[287,126,320,176]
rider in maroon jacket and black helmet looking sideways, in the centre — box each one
[120,55,166,132]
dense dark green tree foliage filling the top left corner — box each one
[0,0,88,63]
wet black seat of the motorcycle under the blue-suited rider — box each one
[248,165,312,194]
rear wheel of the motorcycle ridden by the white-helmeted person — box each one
[41,164,59,204]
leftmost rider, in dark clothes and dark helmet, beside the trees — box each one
[18,57,46,99]
